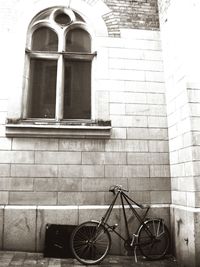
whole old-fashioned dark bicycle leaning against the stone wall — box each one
[71,185,170,265]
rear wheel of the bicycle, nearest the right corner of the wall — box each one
[138,219,170,260]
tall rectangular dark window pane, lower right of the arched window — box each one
[64,60,91,119]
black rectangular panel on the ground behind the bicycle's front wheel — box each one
[44,224,76,258]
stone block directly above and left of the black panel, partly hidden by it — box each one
[36,206,78,251]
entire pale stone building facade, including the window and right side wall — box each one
[0,0,200,266]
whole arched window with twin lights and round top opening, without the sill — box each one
[23,8,95,121]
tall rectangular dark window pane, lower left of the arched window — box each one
[29,59,57,118]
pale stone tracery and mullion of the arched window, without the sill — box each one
[22,13,97,122]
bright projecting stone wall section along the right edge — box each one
[159,1,200,267]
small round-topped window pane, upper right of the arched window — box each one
[66,29,91,52]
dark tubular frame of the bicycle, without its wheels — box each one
[100,190,149,245]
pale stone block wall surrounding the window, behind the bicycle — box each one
[0,0,171,253]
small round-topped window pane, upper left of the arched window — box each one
[32,27,58,51]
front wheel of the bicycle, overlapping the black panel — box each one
[71,221,111,265]
